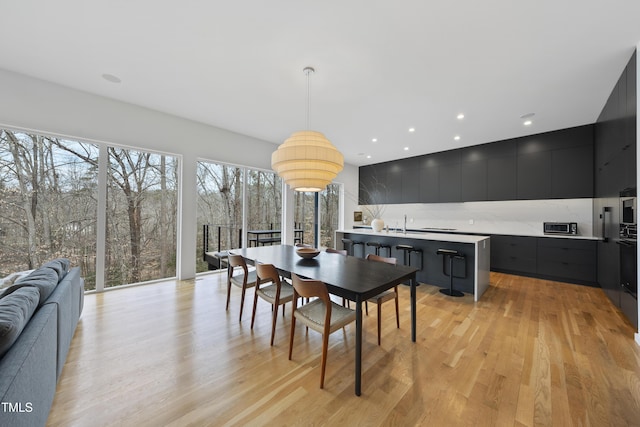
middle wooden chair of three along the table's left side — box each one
[251,264,293,345]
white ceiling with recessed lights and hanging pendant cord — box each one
[0,0,640,165]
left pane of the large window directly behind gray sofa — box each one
[0,129,98,289]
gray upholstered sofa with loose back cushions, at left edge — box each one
[0,259,84,427]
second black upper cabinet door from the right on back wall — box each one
[517,151,551,200]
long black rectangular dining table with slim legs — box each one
[230,245,418,396]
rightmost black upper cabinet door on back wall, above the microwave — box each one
[551,144,594,199]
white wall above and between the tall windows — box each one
[0,69,358,279]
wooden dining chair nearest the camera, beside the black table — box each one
[289,273,356,388]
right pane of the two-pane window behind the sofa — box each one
[105,147,178,287]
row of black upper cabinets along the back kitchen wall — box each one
[360,125,594,204]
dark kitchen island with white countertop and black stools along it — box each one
[336,229,491,301]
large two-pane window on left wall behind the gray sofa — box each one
[0,129,177,290]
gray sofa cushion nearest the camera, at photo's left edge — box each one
[0,286,40,357]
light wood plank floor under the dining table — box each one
[48,273,640,426]
